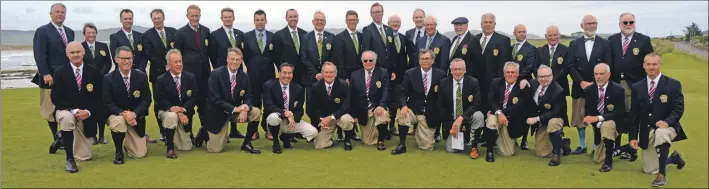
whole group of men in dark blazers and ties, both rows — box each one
[34,3,686,186]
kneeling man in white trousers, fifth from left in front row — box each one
[263,63,318,154]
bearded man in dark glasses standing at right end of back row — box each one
[608,12,654,161]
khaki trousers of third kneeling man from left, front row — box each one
[158,110,192,151]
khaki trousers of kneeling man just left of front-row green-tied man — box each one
[396,109,436,151]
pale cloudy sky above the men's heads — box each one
[0,1,709,37]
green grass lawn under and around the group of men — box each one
[0,44,709,188]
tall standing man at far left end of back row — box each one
[32,3,74,147]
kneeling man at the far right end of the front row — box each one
[629,53,687,187]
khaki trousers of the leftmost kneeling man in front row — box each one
[53,110,92,161]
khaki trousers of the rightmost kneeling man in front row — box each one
[642,127,677,174]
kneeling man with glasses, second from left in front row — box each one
[103,46,152,165]
